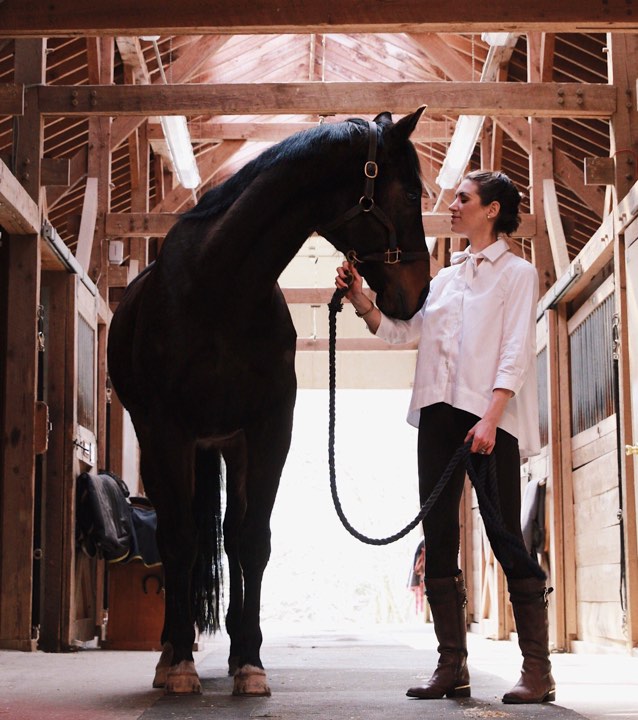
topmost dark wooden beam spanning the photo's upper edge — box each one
[0,0,638,37]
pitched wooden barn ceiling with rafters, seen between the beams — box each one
[0,32,610,286]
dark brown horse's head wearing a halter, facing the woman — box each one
[318,107,430,319]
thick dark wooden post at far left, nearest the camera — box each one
[0,39,44,650]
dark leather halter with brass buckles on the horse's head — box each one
[317,120,428,265]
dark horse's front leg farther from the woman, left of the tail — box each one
[136,422,201,694]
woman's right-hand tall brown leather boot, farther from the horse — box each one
[503,578,556,704]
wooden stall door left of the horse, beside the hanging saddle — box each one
[39,272,103,651]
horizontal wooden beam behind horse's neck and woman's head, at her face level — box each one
[105,212,536,238]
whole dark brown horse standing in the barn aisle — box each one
[108,107,430,695]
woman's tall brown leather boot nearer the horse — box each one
[406,573,470,700]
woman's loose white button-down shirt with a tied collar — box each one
[376,239,540,457]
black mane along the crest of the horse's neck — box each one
[182,118,366,220]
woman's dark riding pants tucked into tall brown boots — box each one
[418,403,532,578]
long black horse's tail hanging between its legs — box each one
[191,448,223,633]
